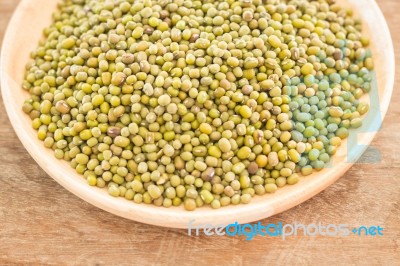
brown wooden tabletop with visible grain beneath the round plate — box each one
[0,0,400,265]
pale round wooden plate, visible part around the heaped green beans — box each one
[1,0,394,228]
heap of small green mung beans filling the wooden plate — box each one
[22,0,373,210]
